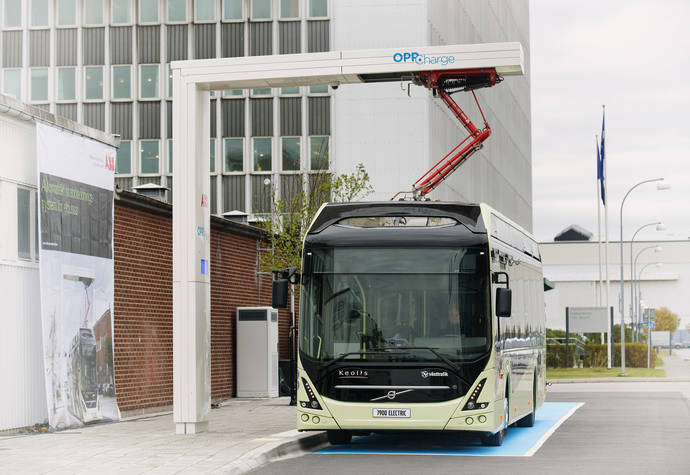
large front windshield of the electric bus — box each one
[300,247,491,362]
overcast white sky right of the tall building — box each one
[530,0,690,244]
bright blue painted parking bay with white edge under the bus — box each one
[315,402,583,457]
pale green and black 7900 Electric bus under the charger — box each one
[297,201,546,446]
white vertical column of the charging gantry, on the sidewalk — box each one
[173,69,211,434]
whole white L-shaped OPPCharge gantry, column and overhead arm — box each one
[171,43,524,434]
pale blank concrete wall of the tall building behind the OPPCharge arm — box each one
[332,0,532,230]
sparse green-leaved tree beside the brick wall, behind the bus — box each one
[260,163,374,271]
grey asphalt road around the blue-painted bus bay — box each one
[251,382,690,475]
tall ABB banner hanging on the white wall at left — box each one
[36,123,120,429]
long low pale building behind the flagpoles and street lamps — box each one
[539,241,690,329]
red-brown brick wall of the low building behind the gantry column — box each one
[113,191,290,415]
